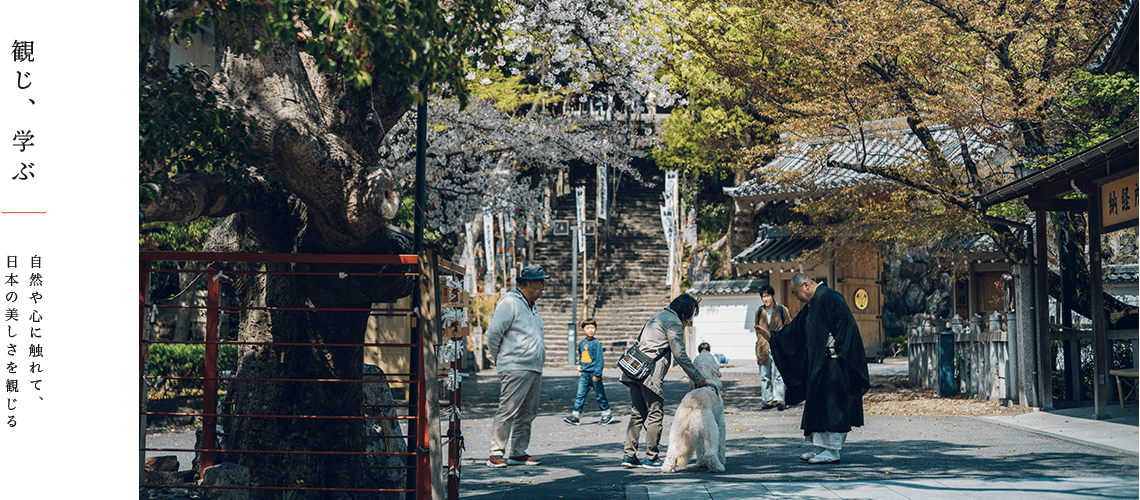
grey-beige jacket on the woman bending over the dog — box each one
[620,308,702,397]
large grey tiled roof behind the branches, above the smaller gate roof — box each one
[724,120,993,198]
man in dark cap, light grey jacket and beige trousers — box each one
[487,265,549,467]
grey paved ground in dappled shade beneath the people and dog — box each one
[461,363,1140,500]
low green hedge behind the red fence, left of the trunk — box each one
[147,344,237,395]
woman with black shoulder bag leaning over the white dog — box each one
[620,294,707,469]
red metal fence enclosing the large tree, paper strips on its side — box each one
[139,251,466,499]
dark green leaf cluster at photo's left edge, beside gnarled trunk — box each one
[139,67,261,220]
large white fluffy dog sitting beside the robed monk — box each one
[661,352,725,473]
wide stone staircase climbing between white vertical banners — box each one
[535,166,671,367]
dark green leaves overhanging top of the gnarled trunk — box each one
[215,0,503,104]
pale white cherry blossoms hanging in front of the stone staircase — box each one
[381,0,677,239]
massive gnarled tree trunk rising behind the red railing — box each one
[140,8,415,499]
